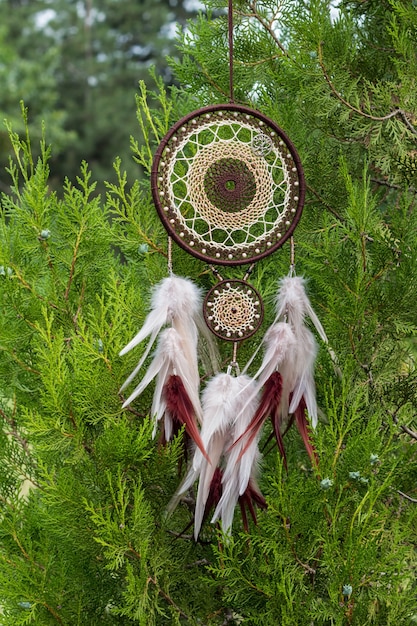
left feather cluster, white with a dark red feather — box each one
[120,275,215,455]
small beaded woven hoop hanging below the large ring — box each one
[203,280,263,341]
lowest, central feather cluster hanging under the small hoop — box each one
[170,374,266,538]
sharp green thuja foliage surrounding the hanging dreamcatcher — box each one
[0,0,417,626]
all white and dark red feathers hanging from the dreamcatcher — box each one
[121,275,327,539]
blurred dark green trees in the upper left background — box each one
[0,0,202,191]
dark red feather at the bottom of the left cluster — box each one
[163,375,210,463]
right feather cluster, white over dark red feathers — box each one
[234,276,327,466]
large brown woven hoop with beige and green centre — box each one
[152,104,304,265]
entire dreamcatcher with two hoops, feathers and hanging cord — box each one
[121,0,327,537]
